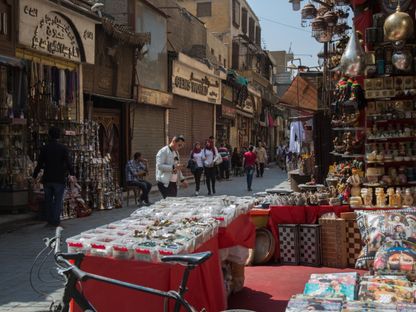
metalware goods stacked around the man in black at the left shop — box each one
[30,120,122,219]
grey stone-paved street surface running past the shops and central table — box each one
[0,167,287,312]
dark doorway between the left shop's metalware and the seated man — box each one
[92,108,121,185]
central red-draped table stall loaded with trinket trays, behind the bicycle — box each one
[66,196,255,311]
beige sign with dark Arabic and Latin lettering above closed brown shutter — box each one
[172,54,221,104]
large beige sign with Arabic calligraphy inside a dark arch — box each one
[19,0,95,64]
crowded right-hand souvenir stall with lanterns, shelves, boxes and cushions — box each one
[260,0,416,311]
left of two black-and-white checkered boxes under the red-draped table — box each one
[278,224,299,265]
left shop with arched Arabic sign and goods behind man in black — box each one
[13,0,121,219]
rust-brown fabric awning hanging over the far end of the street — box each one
[279,76,318,111]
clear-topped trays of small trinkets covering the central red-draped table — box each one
[67,196,254,261]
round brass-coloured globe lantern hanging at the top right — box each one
[384,2,413,42]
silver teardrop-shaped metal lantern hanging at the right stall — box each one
[339,27,365,77]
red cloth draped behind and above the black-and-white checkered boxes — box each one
[268,205,352,261]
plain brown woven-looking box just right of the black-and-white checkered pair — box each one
[319,218,347,268]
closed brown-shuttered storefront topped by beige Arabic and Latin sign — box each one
[169,53,225,163]
